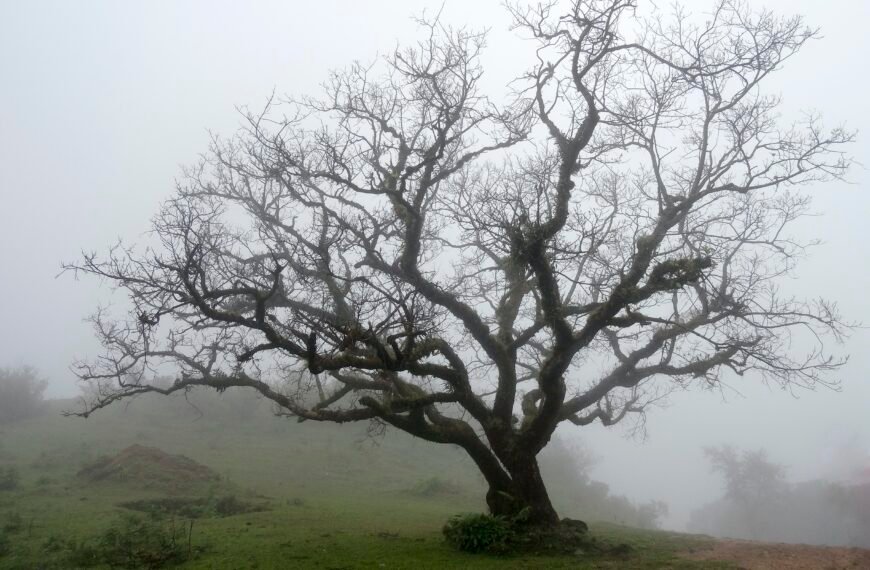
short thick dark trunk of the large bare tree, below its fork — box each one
[486,450,559,526]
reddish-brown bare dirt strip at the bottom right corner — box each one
[685,540,870,570]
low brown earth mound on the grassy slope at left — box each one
[77,445,220,490]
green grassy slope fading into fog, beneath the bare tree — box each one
[0,392,729,569]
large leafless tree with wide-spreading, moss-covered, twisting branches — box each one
[70,0,852,525]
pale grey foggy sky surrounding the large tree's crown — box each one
[0,0,870,527]
